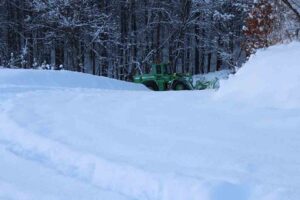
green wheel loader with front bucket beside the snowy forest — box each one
[133,64,218,91]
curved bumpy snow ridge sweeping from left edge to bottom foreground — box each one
[0,114,208,200]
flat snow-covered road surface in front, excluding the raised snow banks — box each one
[0,85,300,200]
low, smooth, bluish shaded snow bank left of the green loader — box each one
[0,69,147,90]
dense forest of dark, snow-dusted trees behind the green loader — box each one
[0,0,300,80]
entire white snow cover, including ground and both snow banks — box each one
[0,43,300,200]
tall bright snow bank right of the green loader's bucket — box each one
[216,42,300,108]
